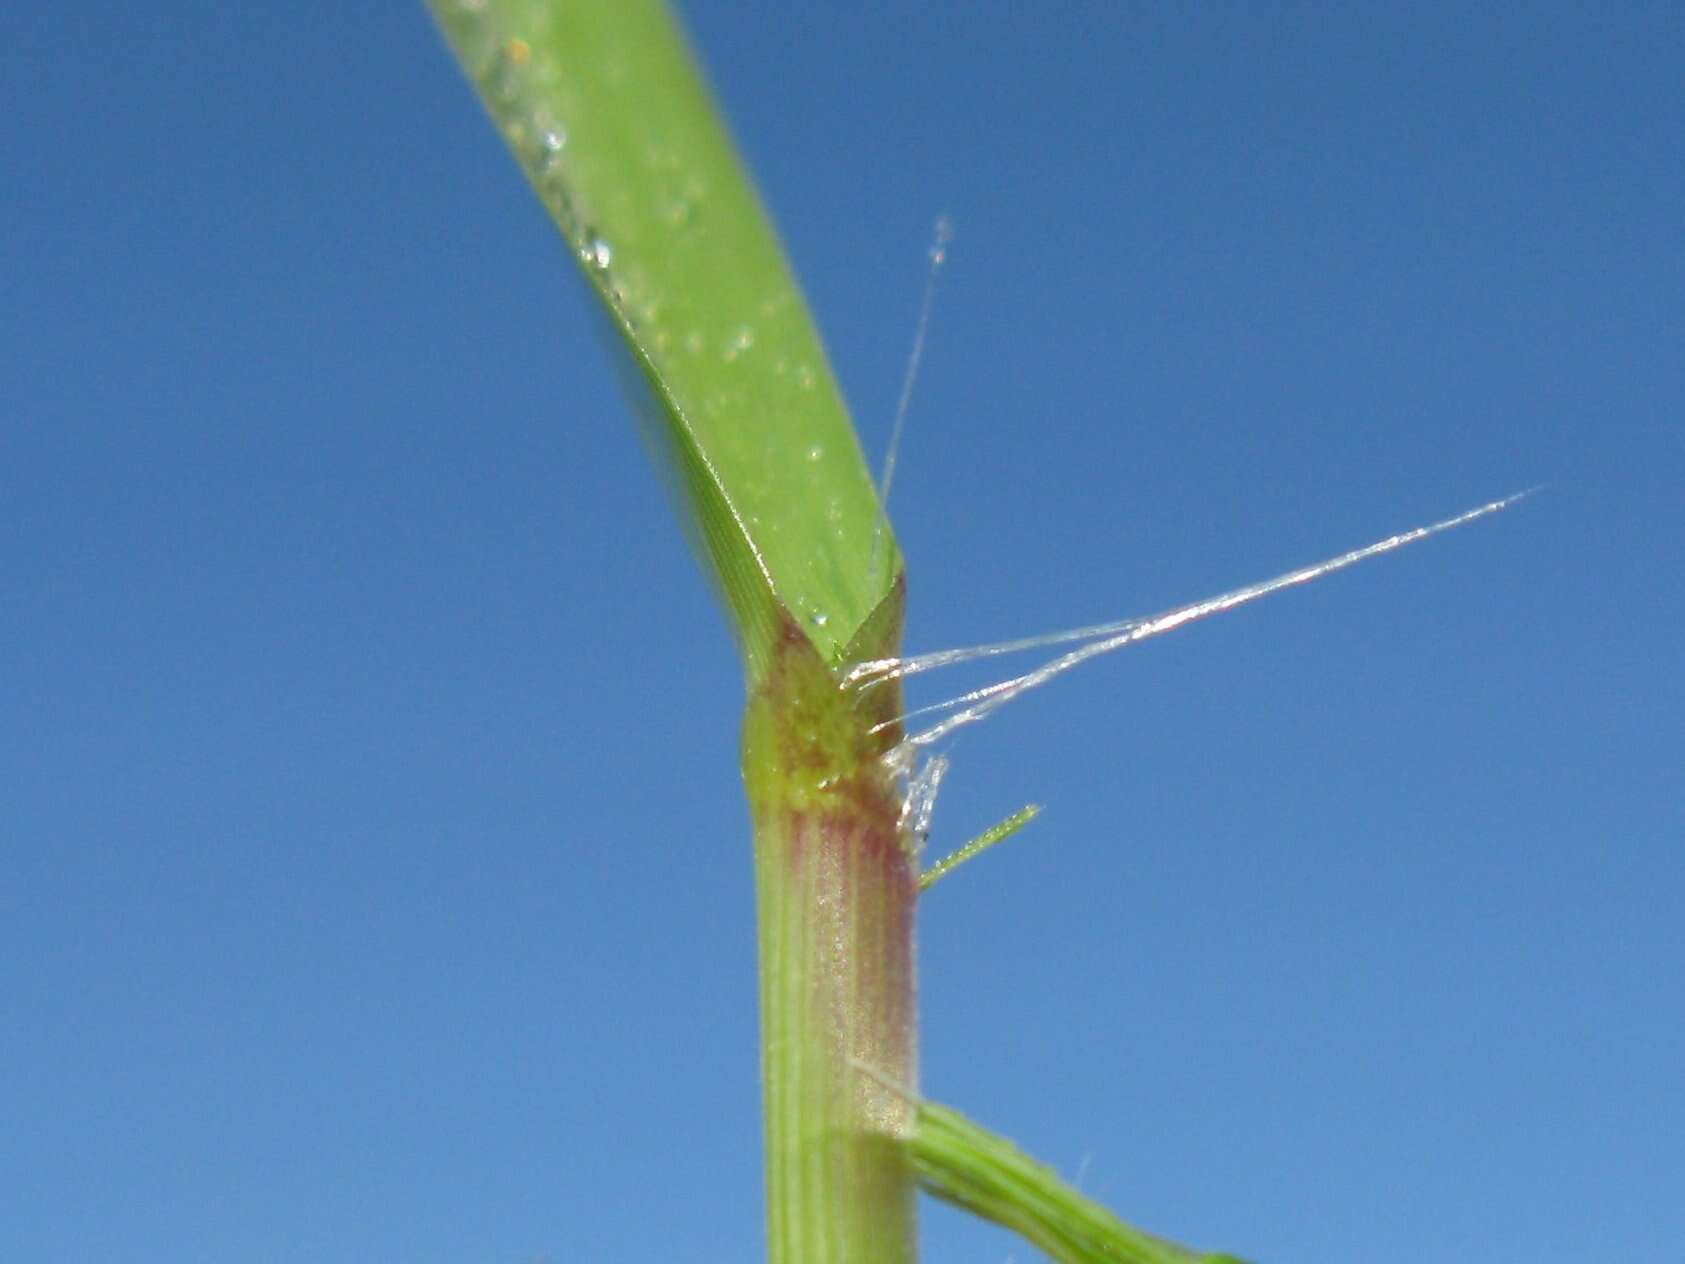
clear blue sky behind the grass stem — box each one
[0,0,1685,1264]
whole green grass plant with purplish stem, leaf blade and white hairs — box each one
[430,0,1508,1264]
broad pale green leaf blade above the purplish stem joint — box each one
[430,0,900,674]
